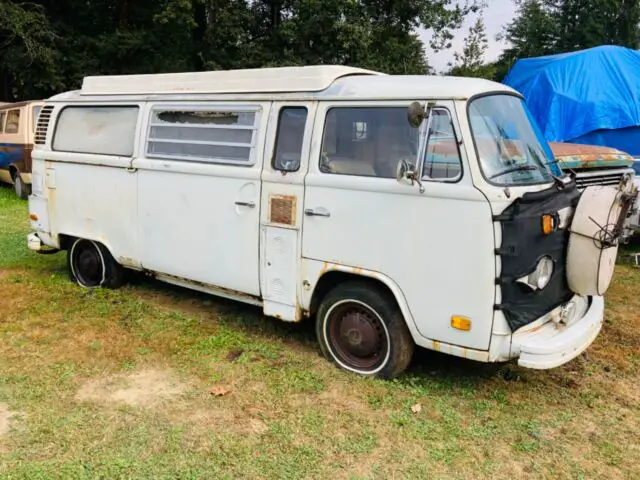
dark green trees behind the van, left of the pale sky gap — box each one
[0,0,477,101]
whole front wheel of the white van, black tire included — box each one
[316,282,415,379]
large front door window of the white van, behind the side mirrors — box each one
[320,107,419,178]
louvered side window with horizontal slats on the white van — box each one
[147,109,259,165]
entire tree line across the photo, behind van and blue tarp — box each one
[0,0,640,101]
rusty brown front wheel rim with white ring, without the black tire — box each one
[324,300,389,373]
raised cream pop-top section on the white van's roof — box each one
[80,65,383,95]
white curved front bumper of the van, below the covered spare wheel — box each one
[511,297,604,370]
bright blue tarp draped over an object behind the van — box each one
[504,46,640,155]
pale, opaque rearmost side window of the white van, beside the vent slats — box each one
[53,106,139,157]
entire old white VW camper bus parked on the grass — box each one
[28,66,629,378]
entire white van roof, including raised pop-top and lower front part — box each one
[48,65,518,102]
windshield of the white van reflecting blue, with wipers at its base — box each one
[469,95,559,185]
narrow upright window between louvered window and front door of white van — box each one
[272,107,307,172]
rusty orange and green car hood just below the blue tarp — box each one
[549,142,633,170]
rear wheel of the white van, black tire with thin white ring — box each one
[67,238,124,288]
